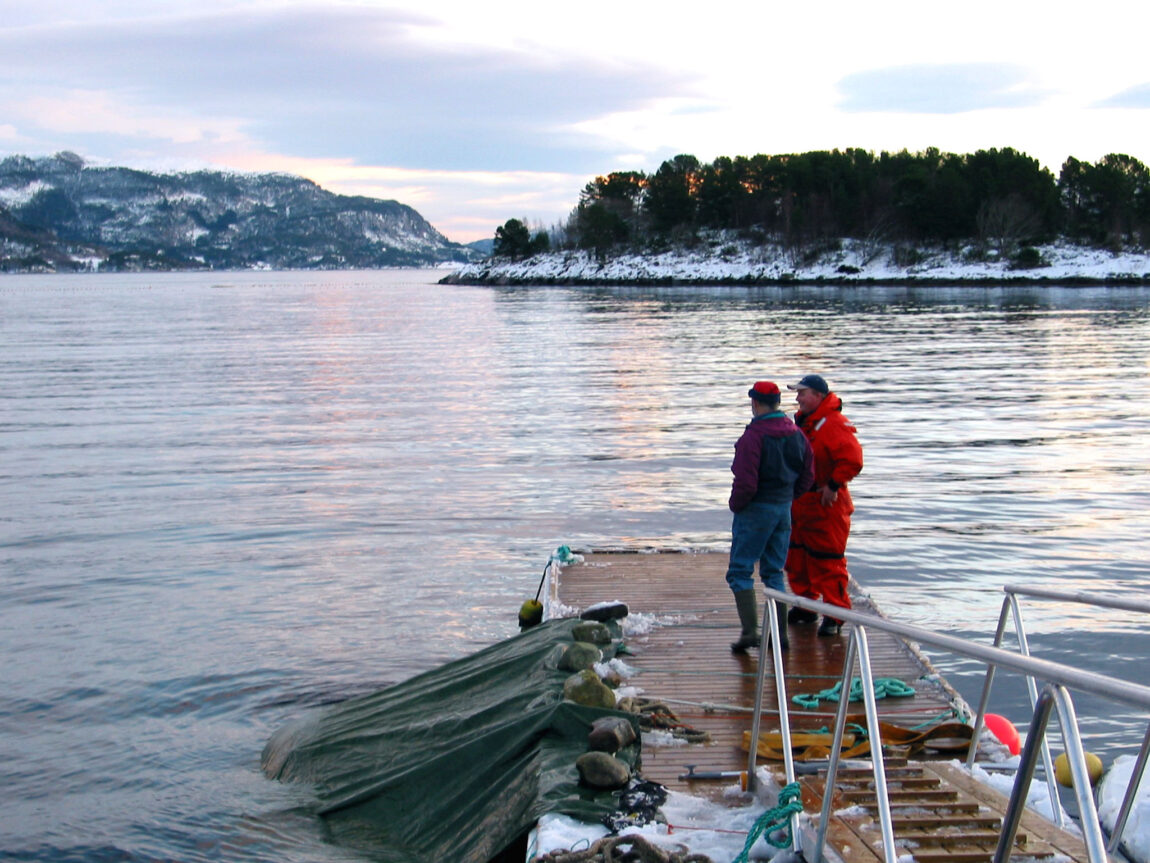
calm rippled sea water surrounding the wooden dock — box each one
[0,272,1150,861]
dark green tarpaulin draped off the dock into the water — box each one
[263,620,638,863]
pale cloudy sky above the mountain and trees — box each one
[0,0,1150,242]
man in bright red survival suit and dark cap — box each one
[785,375,863,635]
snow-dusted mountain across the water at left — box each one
[0,153,478,273]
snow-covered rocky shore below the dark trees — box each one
[442,238,1150,285]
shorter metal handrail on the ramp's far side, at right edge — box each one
[966,585,1150,853]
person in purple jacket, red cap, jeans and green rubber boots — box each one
[727,381,814,654]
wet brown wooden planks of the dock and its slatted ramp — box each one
[550,552,1087,863]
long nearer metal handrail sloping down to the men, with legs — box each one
[748,588,1150,863]
